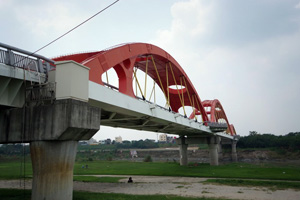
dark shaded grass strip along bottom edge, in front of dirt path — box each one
[0,189,229,200]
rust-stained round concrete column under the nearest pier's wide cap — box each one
[30,141,78,200]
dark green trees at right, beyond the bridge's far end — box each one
[237,131,300,151]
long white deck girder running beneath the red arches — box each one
[89,81,233,139]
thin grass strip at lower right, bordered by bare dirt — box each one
[203,179,300,190]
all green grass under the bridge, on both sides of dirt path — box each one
[0,161,300,200]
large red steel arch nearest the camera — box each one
[53,43,234,134]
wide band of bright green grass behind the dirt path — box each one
[0,161,300,181]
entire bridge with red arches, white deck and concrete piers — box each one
[0,43,238,199]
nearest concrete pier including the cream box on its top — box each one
[0,61,101,200]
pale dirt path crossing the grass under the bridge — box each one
[0,176,300,200]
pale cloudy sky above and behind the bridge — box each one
[0,0,300,140]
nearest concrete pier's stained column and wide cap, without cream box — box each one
[0,99,101,200]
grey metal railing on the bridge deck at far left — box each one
[0,43,55,74]
